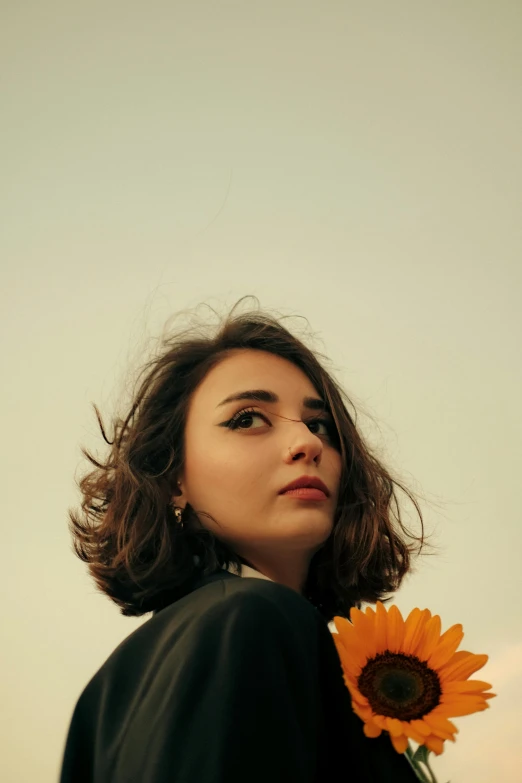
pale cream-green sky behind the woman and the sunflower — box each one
[0,0,522,783]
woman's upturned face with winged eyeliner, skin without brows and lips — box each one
[173,349,341,576]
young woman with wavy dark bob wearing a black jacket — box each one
[60,298,422,783]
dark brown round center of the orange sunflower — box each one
[357,650,442,720]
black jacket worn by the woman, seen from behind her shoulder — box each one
[60,570,417,783]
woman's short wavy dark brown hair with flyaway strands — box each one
[68,297,424,622]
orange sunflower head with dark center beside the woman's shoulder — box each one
[332,601,495,755]
